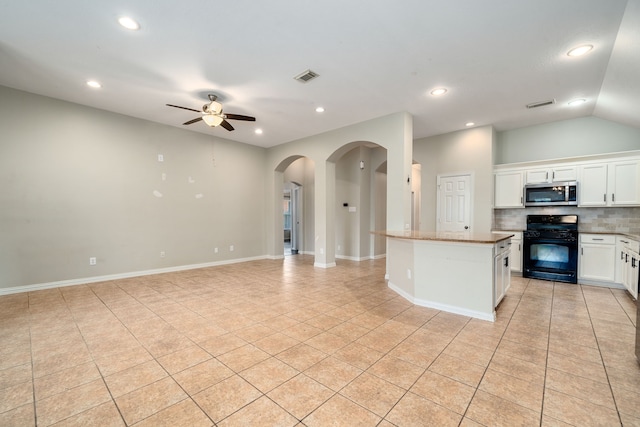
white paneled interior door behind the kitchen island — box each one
[437,175,472,232]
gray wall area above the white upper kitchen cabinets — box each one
[495,117,640,164]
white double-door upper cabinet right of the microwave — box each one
[578,159,640,206]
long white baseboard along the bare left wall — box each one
[0,255,269,295]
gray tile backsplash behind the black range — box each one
[493,206,640,236]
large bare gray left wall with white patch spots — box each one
[0,87,266,288]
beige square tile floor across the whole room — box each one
[0,255,640,426]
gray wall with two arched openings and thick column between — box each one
[265,112,413,268]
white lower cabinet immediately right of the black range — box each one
[578,234,616,283]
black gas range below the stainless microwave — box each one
[522,215,578,283]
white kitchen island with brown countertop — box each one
[374,231,512,322]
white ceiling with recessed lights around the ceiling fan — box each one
[0,0,640,147]
